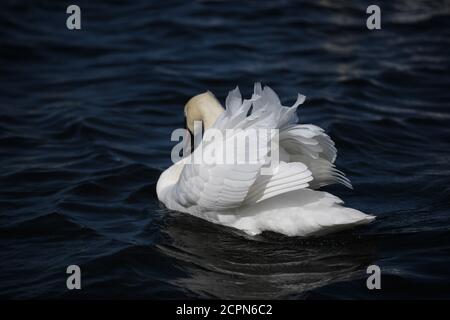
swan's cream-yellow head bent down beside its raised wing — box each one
[184,91,225,133]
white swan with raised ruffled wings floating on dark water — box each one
[156,83,375,237]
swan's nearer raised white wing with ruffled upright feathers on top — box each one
[172,84,312,212]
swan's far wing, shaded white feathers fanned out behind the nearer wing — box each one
[280,124,352,188]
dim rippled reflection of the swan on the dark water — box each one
[159,212,374,299]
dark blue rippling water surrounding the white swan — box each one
[0,0,450,299]
